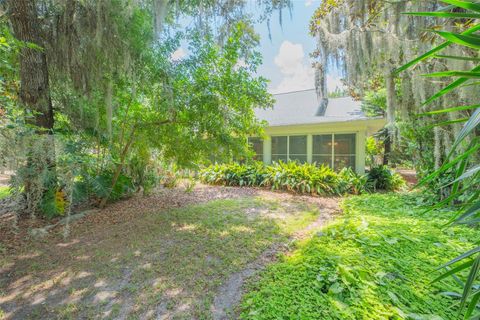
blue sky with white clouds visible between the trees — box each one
[172,0,342,94]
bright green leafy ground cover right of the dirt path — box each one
[241,194,478,319]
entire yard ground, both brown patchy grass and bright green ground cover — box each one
[0,186,477,319]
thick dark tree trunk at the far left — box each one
[7,0,55,214]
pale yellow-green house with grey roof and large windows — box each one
[249,89,386,173]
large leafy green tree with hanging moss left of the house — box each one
[2,0,284,215]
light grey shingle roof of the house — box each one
[255,89,369,127]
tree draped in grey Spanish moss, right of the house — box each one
[311,0,479,171]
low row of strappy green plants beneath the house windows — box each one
[200,162,401,195]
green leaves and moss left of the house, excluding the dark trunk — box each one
[0,0,278,216]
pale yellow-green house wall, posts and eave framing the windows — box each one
[263,119,386,174]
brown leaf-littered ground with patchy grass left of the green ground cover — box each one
[0,185,338,319]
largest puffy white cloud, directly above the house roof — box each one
[271,41,315,93]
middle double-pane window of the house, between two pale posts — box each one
[272,136,307,162]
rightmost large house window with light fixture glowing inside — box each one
[312,134,356,170]
